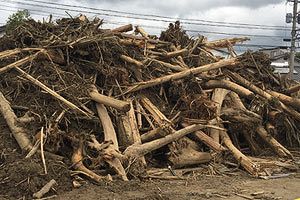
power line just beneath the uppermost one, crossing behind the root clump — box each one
[1,0,289,31]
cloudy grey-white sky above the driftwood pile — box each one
[0,0,292,48]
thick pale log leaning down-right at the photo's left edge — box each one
[0,92,33,151]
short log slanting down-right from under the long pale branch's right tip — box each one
[181,123,226,152]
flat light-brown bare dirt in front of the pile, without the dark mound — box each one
[56,174,300,200]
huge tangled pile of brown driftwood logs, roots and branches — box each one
[0,16,300,182]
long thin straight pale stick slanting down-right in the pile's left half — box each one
[14,66,91,118]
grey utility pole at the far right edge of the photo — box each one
[287,0,298,79]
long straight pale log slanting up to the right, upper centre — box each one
[125,58,238,93]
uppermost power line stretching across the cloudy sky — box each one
[23,0,287,28]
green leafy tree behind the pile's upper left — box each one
[5,10,30,34]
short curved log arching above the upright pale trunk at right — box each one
[203,80,255,100]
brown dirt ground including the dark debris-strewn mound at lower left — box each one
[0,119,300,200]
